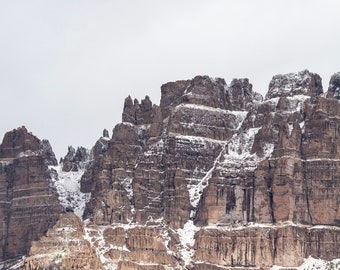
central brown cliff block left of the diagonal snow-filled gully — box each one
[82,76,258,228]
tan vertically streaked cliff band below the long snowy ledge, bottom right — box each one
[194,225,340,269]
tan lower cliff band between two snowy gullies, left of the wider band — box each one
[85,224,181,269]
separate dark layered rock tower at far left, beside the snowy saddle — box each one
[0,127,62,261]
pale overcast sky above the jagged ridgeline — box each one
[0,0,340,157]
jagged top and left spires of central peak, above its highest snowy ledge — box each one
[122,76,262,132]
